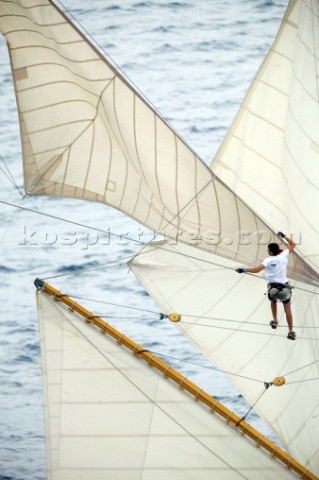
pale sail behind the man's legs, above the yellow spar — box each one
[129,242,319,475]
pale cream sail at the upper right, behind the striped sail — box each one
[212,0,319,268]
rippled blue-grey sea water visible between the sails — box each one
[0,0,287,480]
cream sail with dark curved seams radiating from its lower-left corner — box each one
[0,0,317,281]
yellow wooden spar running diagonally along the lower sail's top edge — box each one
[35,279,319,480]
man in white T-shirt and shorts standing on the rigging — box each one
[236,232,296,340]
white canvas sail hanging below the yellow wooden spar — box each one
[38,292,314,480]
